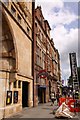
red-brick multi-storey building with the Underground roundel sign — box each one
[33,6,61,106]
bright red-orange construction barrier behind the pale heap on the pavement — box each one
[59,97,80,112]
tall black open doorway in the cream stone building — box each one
[22,81,29,107]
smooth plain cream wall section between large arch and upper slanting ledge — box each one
[6,10,32,76]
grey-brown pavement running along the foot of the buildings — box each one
[6,102,80,120]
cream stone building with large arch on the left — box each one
[0,0,33,119]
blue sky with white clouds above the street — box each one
[35,0,80,83]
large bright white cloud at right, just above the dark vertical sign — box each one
[51,25,78,53]
